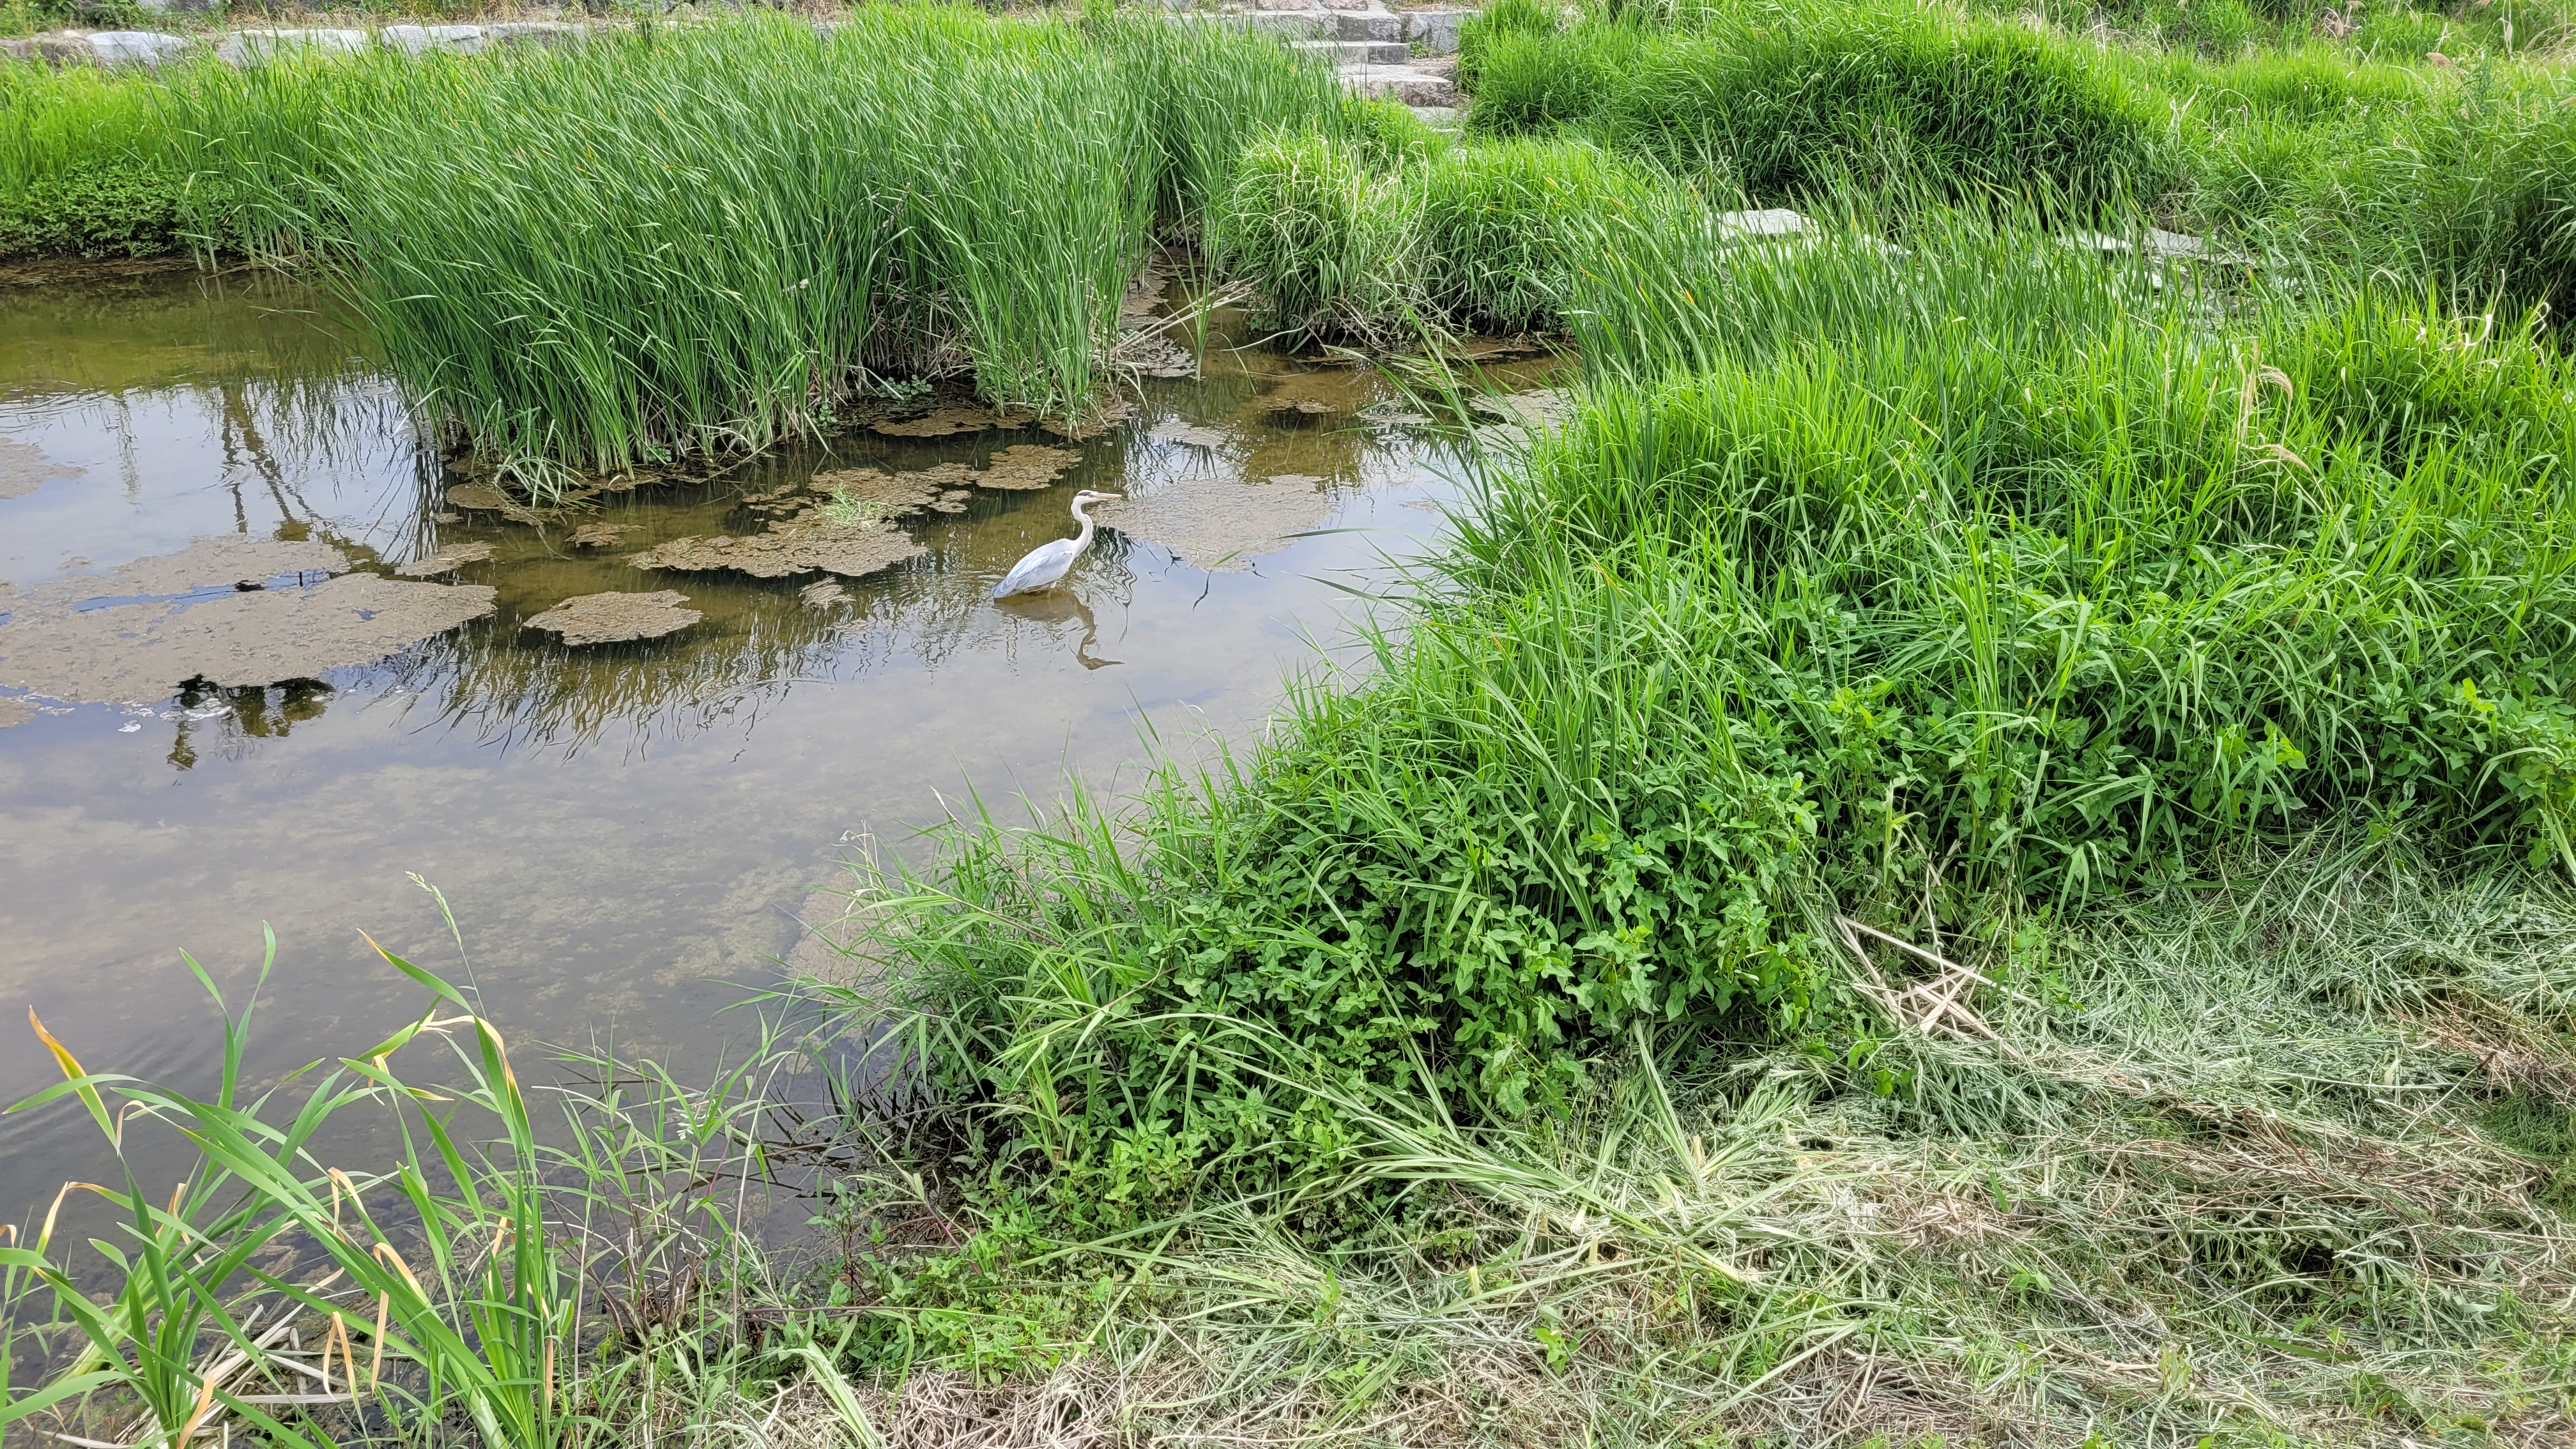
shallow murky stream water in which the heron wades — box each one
[0,271,1545,1217]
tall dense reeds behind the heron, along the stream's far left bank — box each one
[13,5,1345,482]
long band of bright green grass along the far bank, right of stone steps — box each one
[1471,0,2576,319]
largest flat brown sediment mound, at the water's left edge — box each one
[0,536,492,704]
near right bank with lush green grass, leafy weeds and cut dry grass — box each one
[788,217,2576,1444]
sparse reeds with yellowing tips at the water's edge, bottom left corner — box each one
[0,902,814,1449]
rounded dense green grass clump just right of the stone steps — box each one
[1471,5,2174,204]
